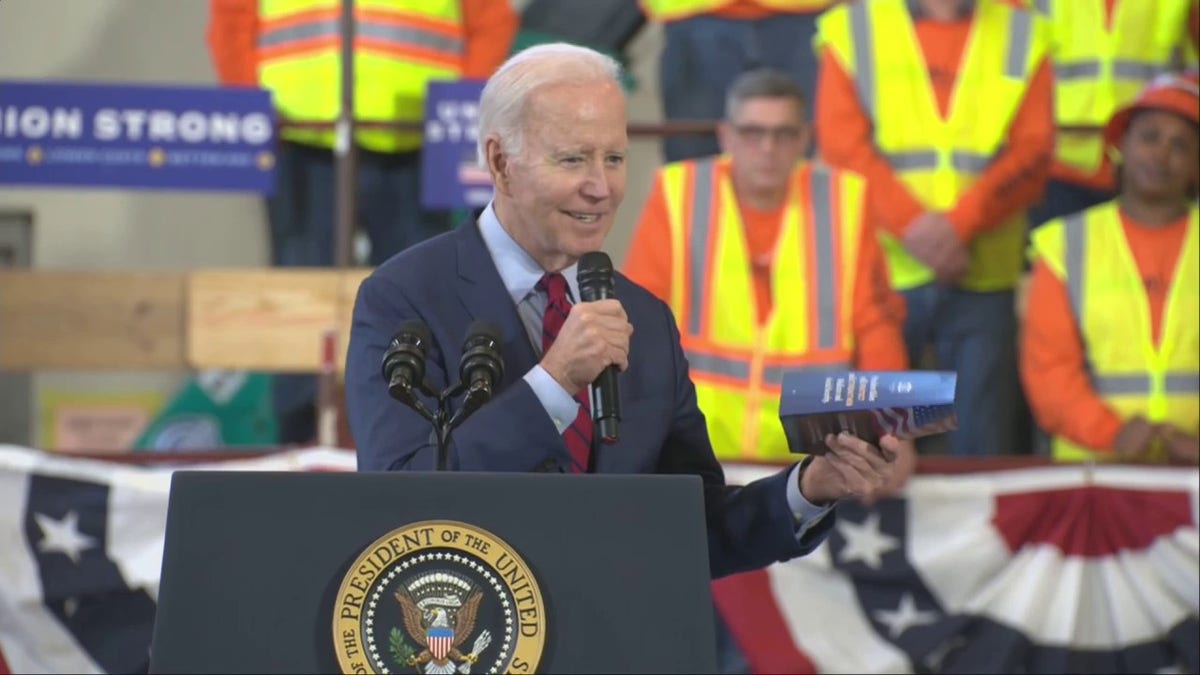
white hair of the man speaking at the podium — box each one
[475,42,620,166]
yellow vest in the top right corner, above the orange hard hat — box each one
[1033,0,1195,174]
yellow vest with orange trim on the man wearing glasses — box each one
[661,157,864,460]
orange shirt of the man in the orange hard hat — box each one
[1021,213,1188,452]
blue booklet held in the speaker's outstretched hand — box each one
[779,370,958,455]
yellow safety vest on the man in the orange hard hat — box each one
[1032,202,1200,461]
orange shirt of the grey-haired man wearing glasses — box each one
[623,163,908,370]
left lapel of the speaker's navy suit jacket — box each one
[455,221,538,387]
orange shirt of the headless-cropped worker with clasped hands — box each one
[816,0,1055,243]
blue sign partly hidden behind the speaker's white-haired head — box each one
[421,79,492,210]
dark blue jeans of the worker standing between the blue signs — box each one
[266,141,450,444]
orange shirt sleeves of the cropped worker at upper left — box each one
[206,0,521,86]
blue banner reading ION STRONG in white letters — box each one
[0,80,276,193]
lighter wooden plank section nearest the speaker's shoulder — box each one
[187,268,341,372]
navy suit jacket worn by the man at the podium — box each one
[346,222,834,578]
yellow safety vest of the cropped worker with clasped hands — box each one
[817,0,1049,291]
